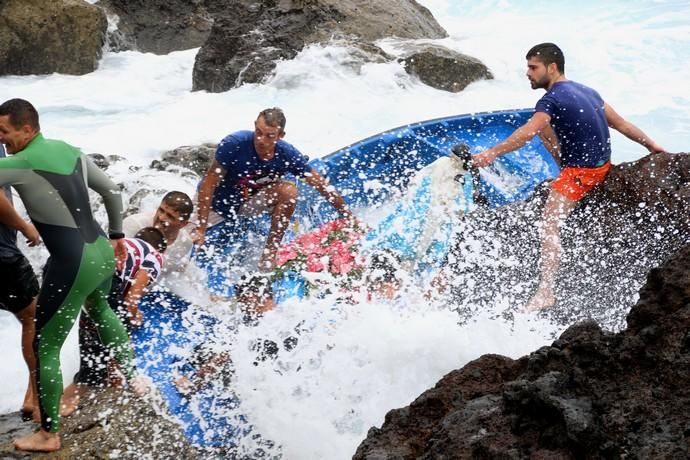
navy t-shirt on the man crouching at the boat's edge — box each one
[212,131,312,217]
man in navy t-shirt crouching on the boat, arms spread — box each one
[196,107,352,271]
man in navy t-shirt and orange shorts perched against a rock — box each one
[474,43,664,311]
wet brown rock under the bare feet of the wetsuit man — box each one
[0,388,196,460]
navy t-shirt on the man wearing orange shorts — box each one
[535,81,611,168]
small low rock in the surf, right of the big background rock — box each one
[402,45,494,93]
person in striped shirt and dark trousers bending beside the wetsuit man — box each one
[60,227,167,416]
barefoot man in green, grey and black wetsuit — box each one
[0,99,137,452]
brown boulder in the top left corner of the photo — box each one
[0,0,107,75]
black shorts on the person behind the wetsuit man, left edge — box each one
[0,255,38,313]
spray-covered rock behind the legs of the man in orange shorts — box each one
[449,153,690,330]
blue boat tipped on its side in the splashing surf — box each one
[133,110,558,448]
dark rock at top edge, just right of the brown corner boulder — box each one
[98,0,212,54]
